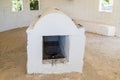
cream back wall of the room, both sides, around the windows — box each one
[0,0,120,35]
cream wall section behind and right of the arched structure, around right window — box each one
[41,0,120,35]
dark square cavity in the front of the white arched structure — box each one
[43,36,65,60]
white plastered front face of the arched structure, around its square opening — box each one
[27,8,85,74]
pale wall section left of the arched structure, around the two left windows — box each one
[0,0,40,32]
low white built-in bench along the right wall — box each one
[75,20,116,36]
